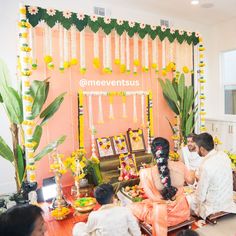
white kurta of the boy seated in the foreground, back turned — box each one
[72,204,141,236]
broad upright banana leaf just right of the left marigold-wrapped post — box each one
[30,80,46,118]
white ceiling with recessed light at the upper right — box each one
[101,0,236,25]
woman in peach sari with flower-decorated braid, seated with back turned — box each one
[130,138,194,236]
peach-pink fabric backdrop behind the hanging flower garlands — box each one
[32,29,173,185]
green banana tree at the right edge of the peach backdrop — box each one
[159,74,198,144]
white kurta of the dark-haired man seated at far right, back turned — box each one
[187,150,236,219]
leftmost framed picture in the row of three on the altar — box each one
[96,137,115,157]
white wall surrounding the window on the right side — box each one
[206,18,236,121]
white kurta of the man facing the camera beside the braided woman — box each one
[182,146,202,171]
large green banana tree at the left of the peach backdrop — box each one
[0,60,66,192]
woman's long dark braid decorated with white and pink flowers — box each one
[151,137,177,200]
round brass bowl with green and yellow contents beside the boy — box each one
[73,197,96,213]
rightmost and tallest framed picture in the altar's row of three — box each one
[127,129,146,152]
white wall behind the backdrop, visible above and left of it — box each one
[0,0,208,194]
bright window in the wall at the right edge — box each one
[221,50,236,115]
